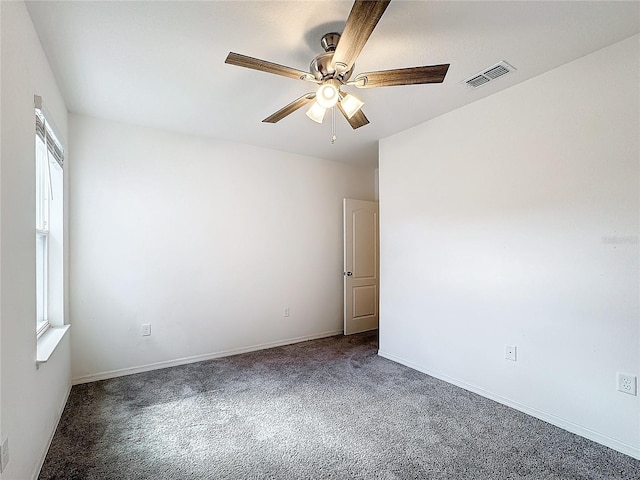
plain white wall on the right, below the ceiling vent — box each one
[380,36,640,458]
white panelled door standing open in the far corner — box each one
[343,198,378,335]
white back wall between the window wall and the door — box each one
[70,114,374,382]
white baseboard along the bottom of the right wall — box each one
[378,350,640,460]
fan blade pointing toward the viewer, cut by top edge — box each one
[333,0,391,73]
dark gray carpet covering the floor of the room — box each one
[39,333,640,480]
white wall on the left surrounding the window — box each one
[0,2,71,480]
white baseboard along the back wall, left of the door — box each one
[71,330,342,385]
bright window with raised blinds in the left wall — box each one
[35,102,64,336]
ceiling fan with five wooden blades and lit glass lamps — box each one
[225,0,449,135]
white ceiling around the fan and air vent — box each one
[27,0,640,165]
